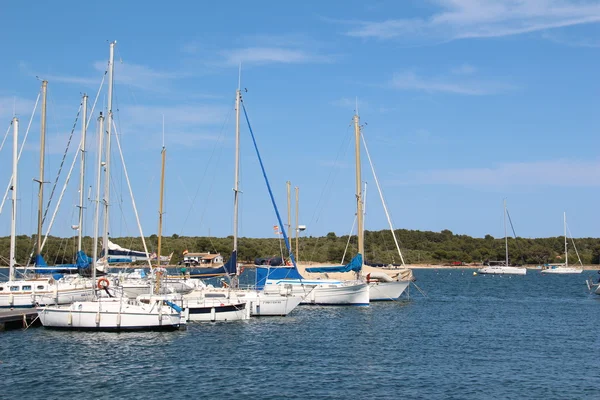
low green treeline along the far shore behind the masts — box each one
[0,229,600,265]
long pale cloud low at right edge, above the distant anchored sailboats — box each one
[394,160,600,187]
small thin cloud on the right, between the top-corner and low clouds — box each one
[390,71,515,96]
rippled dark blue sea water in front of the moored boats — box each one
[0,269,600,399]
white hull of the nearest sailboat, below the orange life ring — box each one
[37,298,185,331]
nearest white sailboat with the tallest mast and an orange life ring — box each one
[37,42,186,331]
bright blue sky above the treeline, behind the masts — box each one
[0,0,600,244]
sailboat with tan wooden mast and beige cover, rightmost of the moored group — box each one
[306,107,412,301]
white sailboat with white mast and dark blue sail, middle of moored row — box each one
[177,85,302,320]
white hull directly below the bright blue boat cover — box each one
[265,279,369,306]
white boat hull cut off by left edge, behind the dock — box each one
[0,279,93,308]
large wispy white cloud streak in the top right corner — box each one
[346,0,600,42]
